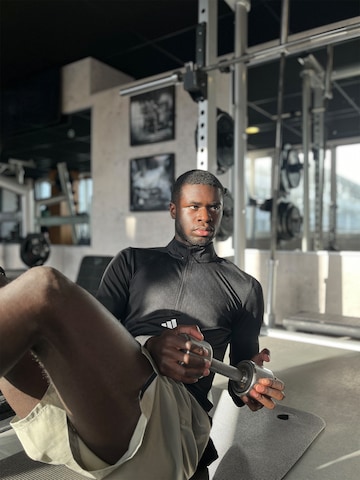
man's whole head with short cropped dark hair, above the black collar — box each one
[170,170,224,246]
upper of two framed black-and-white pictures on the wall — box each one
[130,85,175,146]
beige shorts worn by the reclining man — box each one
[11,349,210,480]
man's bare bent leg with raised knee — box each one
[0,267,152,463]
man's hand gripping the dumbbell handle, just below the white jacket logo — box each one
[146,325,210,383]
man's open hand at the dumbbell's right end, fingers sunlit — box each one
[241,348,285,411]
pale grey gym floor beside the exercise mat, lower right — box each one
[0,336,360,480]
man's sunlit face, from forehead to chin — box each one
[170,184,223,246]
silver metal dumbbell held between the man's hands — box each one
[184,334,274,397]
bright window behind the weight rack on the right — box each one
[246,144,360,250]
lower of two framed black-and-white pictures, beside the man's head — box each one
[130,153,175,212]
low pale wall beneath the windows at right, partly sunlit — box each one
[245,249,360,326]
